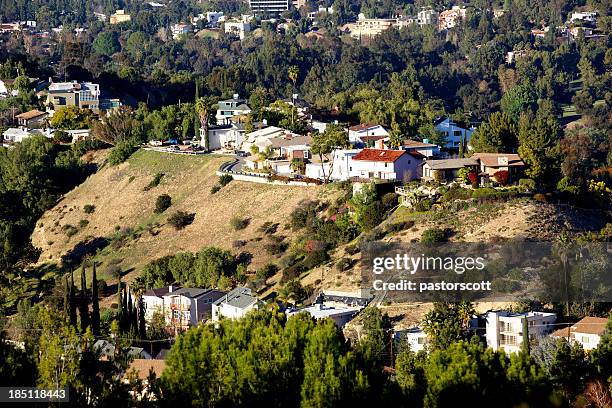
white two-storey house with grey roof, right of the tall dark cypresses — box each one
[142,285,225,332]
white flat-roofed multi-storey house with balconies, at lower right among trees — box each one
[485,311,557,353]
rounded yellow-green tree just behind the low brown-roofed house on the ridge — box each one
[470,112,518,153]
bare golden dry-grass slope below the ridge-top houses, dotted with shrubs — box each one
[32,151,334,280]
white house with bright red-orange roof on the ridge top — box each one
[349,148,422,180]
